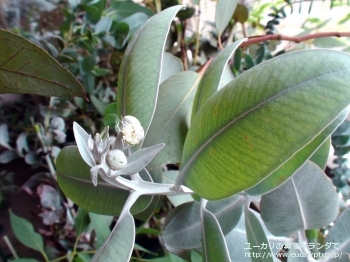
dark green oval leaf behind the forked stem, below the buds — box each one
[56,146,152,216]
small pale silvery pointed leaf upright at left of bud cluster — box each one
[73,122,95,167]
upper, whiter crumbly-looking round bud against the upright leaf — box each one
[121,116,145,145]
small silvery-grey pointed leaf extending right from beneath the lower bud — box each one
[112,144,164,176]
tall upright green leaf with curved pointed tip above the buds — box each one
[117,6,184,137]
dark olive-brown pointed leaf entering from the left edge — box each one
[0,30,86,98]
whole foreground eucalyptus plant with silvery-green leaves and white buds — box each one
[56,6,350,261]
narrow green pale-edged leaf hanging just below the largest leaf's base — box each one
[200,200,231,262]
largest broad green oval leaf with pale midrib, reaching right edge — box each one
[177,50,350,199]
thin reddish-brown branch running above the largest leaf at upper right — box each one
[240,32,350,47]
